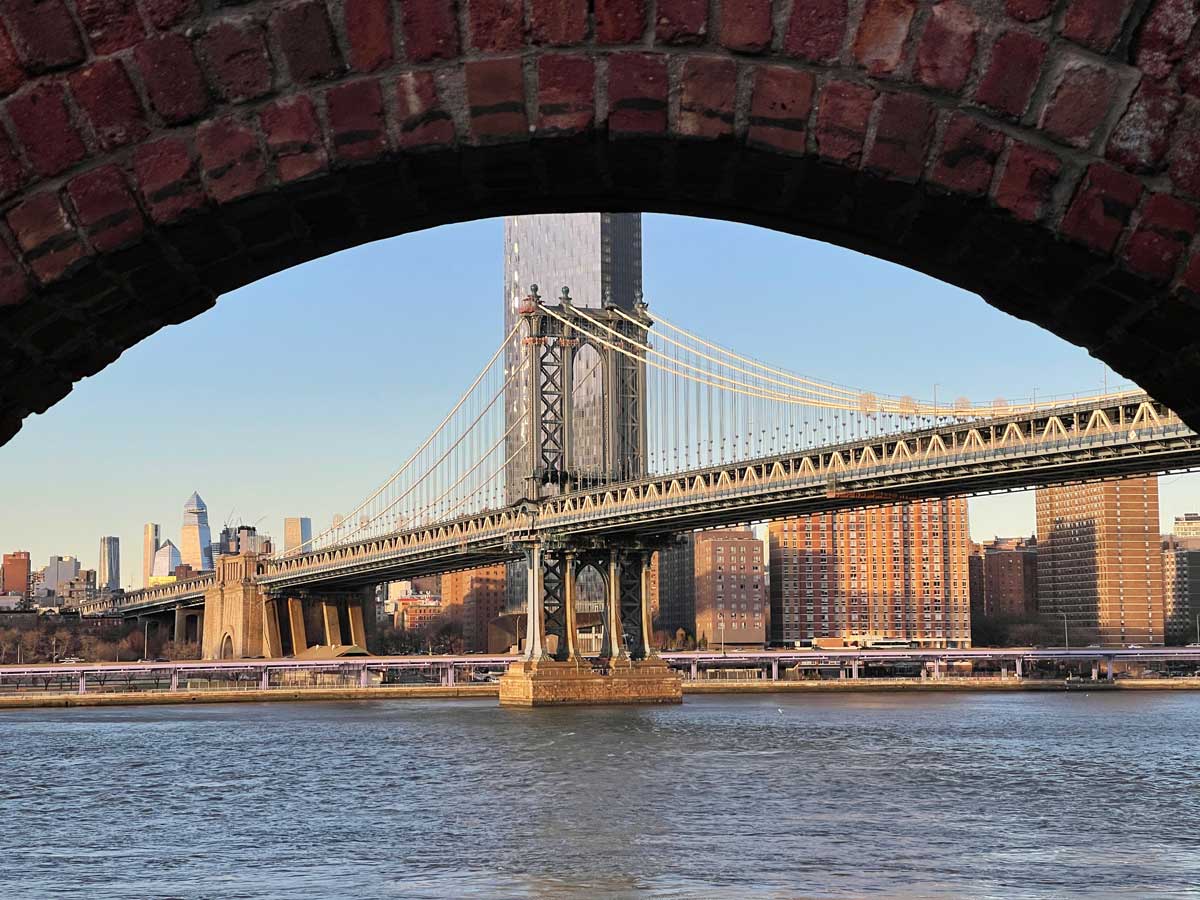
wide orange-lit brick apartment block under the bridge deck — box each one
[770,498,971,647]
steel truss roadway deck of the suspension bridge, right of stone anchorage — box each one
[256,394,1200,593]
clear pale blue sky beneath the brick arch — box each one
[0,215,1200,586]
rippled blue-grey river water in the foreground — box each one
[0,692,1200,900]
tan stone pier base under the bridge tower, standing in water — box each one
[499,659,683,707]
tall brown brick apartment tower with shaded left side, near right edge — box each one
[1036,476,1165,647]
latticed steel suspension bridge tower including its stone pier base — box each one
[500,284,682,706]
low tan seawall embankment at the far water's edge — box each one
[0,678,1200,710]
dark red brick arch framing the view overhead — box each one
[0,0,1200,443]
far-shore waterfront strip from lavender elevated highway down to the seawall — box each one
[0,647,1200,709]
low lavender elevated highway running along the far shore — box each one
[0,647,1200,692]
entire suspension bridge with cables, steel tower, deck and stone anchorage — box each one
[98,286,1200,691]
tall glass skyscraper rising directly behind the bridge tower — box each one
[504,212,642,608]
